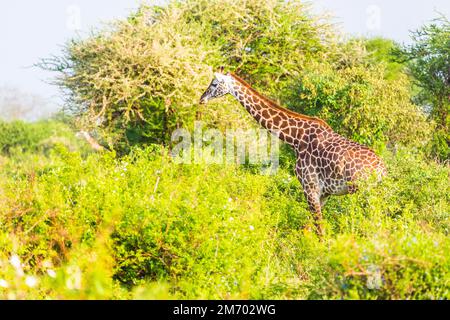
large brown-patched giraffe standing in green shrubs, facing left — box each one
[200,67,387,237]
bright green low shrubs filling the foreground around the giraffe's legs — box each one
[0,141,450,299]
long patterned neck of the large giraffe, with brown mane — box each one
[231,74,333,148]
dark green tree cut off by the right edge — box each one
[397,17,450,160]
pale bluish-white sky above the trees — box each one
[0,0,450,117]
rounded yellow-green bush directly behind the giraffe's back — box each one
[285,56,432,146]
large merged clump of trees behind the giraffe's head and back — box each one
[44,0,431,152]
